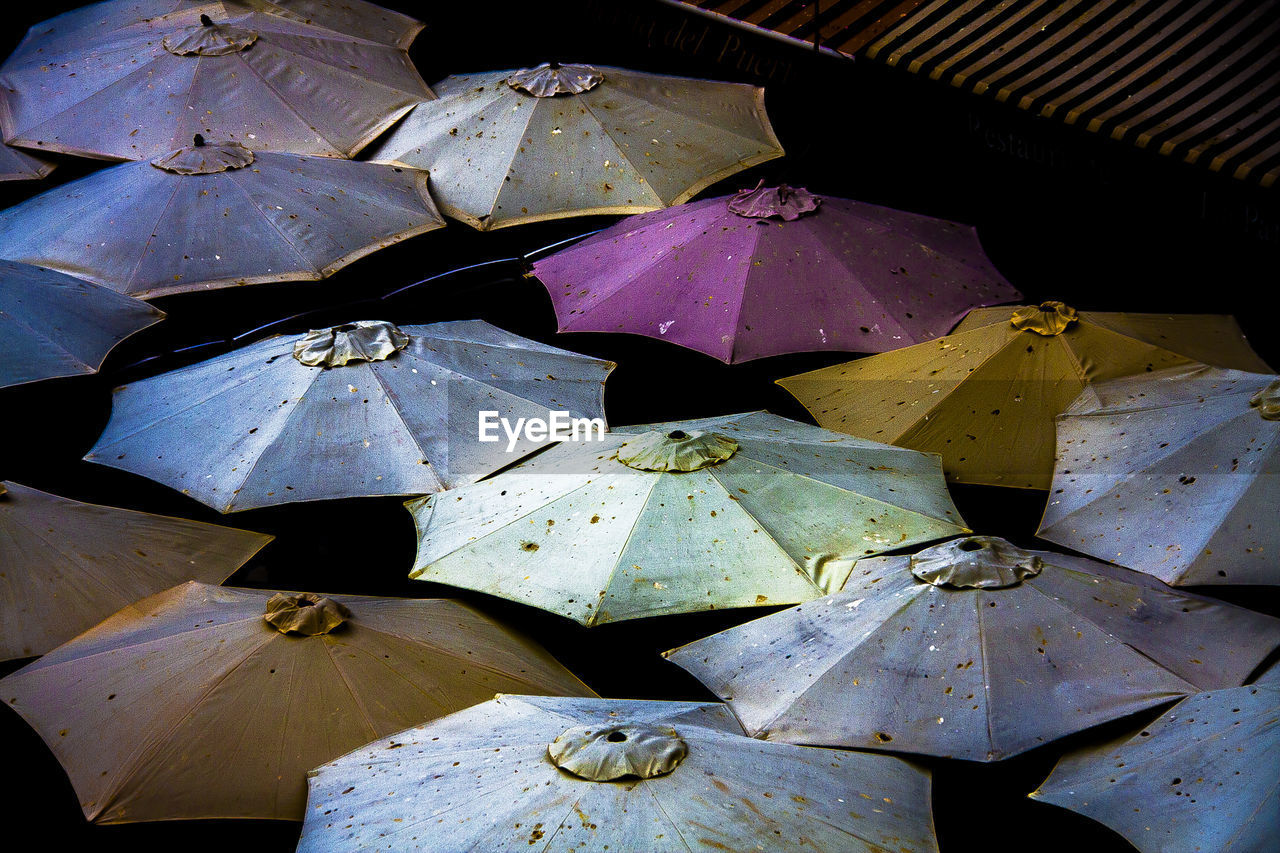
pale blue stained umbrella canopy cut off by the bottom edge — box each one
[298,695,937,853]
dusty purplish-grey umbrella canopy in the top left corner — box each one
[0,0,433,160]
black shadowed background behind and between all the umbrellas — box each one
[0,0,1280,853]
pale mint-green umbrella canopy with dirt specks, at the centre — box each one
[406,411,966,625]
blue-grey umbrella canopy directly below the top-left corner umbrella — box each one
[0,137,444,297]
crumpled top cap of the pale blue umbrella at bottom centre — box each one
[547,722,689,781]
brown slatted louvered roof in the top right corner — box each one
[682,0,1280,187]
